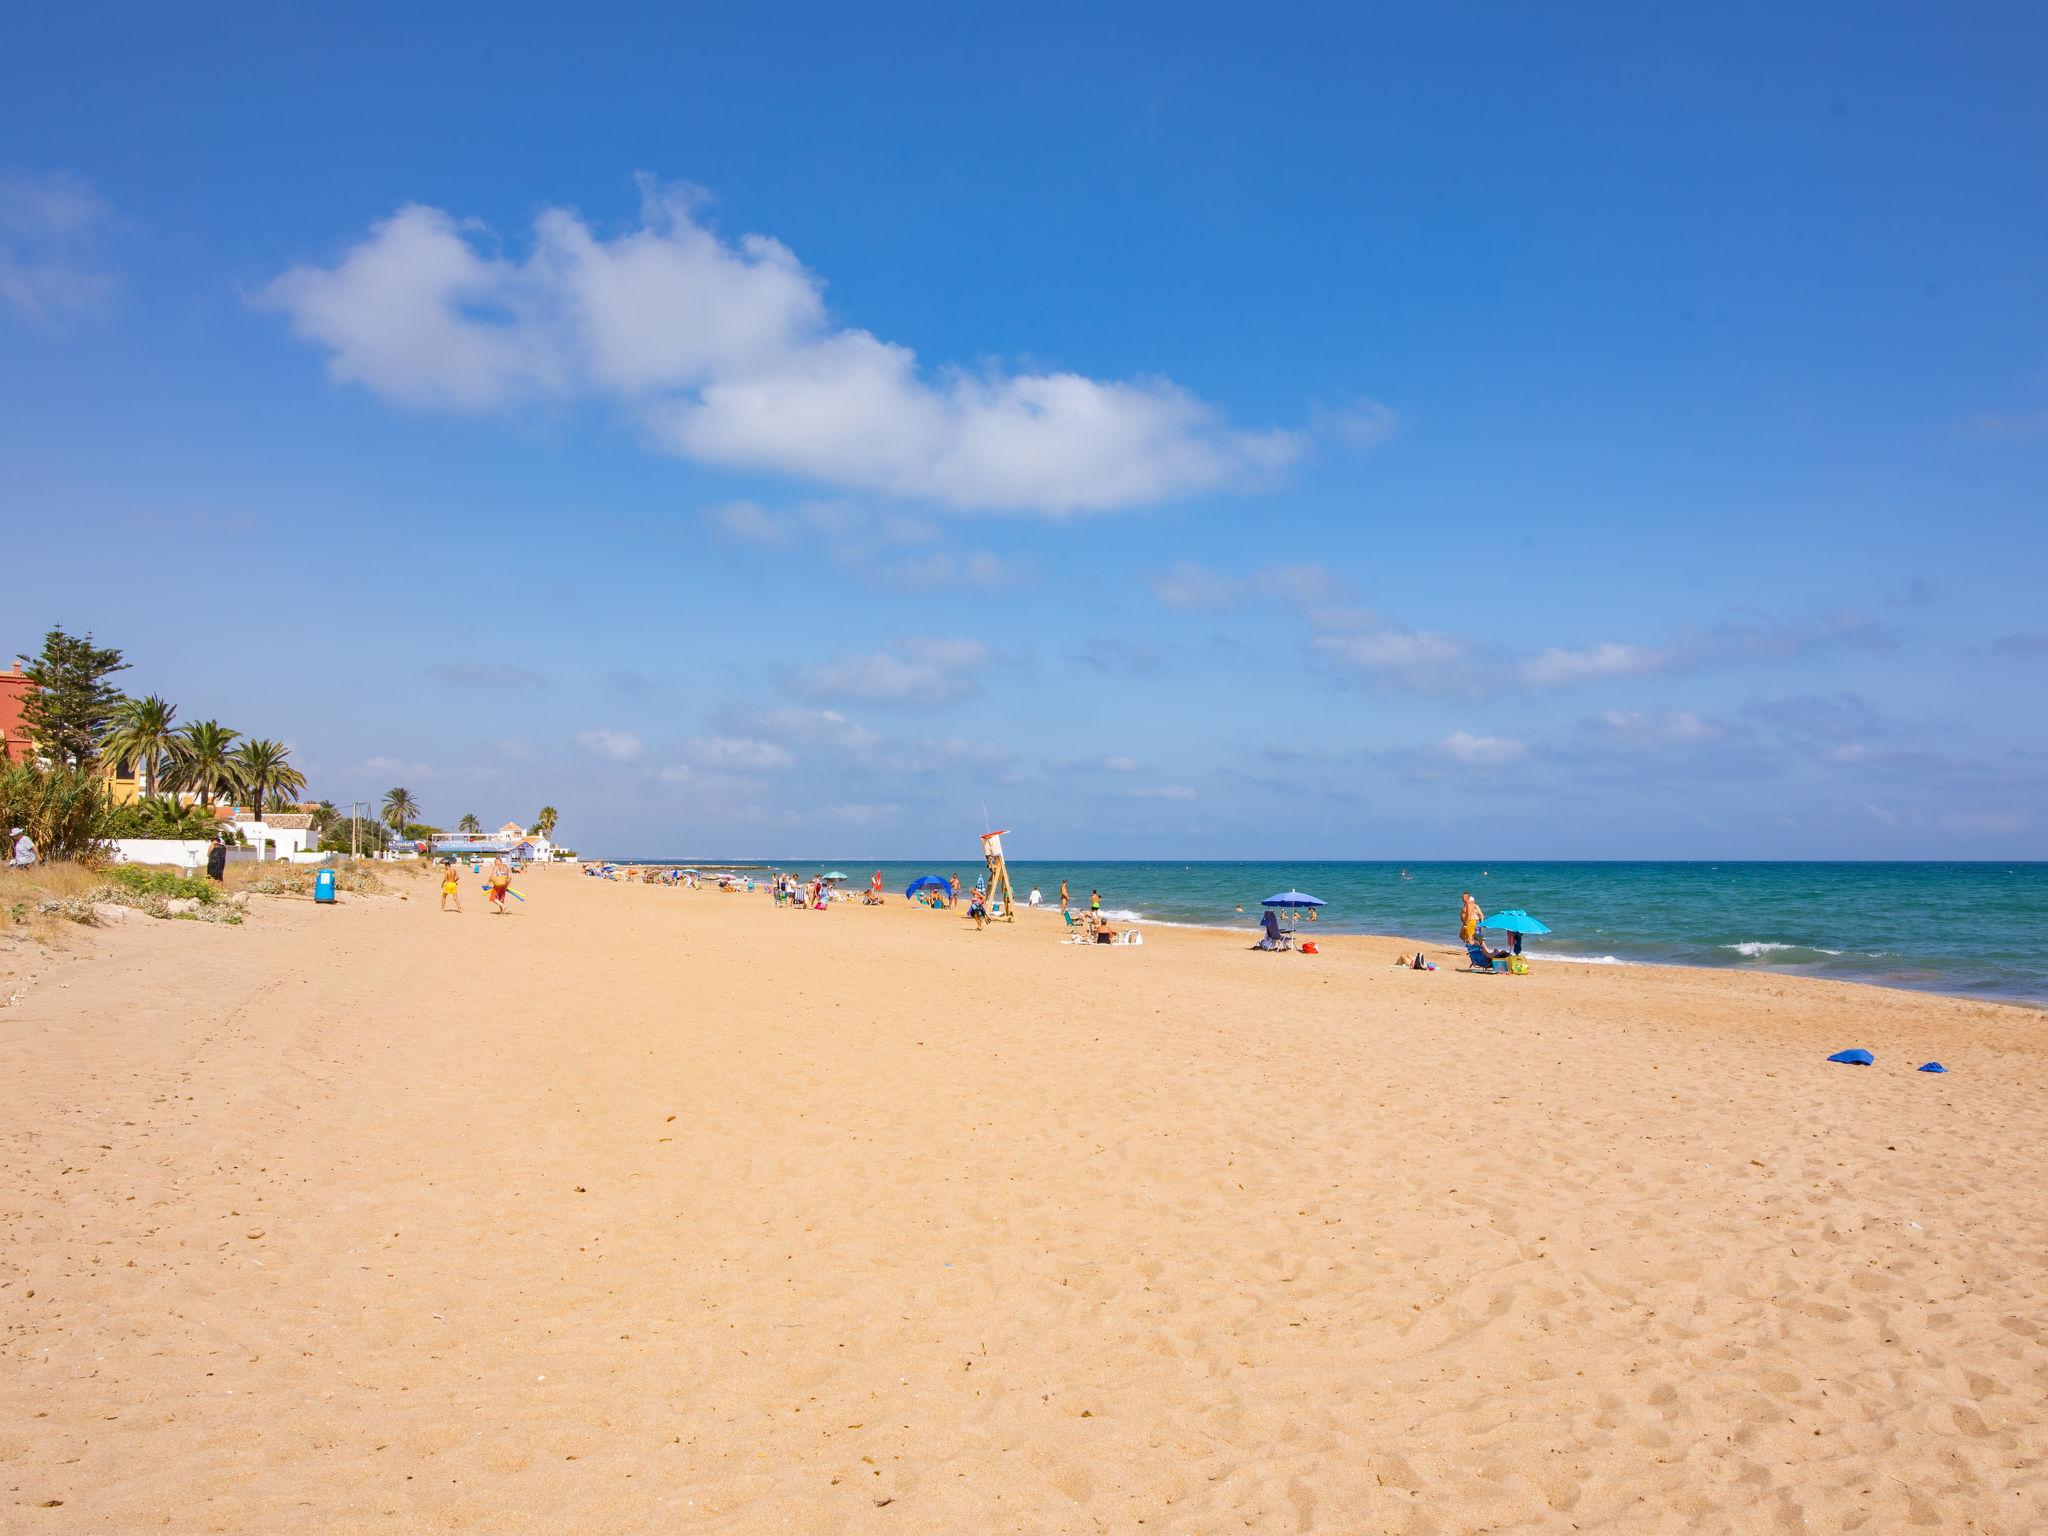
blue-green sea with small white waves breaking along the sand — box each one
[629,858,2048,1004]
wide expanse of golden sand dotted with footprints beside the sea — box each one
[0,870,2048,1536]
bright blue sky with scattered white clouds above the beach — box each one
[0,4,2048,860]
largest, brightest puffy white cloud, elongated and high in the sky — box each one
[258,180,1305,514]
